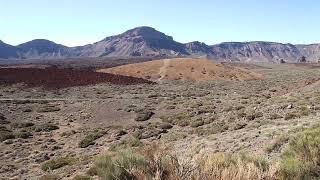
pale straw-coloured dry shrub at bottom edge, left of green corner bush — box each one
[198,153,278,180]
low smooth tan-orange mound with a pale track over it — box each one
[98,58,262,81]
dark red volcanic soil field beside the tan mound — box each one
[0,68,153,89]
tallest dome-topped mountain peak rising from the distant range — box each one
[70,27,188,57]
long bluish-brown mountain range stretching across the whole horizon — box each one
[0,26,320,62]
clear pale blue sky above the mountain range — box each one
[0,0,320,46]
